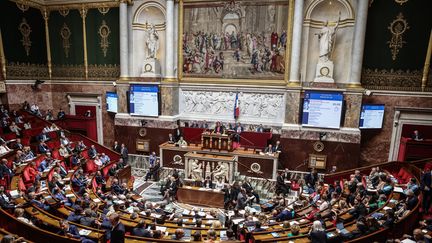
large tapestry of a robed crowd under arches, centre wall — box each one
[183,1,288,79]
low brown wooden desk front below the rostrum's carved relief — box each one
[177,187,224,208]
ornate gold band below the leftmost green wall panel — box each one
[6,62,49,79]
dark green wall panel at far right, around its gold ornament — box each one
[363,0,432,70]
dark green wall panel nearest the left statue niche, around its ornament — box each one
[86,8,120,65]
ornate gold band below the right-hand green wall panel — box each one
[362,69,430,91]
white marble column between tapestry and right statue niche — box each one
[288,0,304,86]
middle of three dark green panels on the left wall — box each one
[49,9,84,65]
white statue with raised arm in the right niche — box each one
[316,13,340,62]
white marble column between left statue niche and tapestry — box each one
[165,0,174,79]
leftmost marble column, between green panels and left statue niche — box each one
[119,0,129,78]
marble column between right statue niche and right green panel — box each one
[348,0,369,87]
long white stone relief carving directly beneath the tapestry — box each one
[181,91,284,122]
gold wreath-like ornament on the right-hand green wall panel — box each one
[387,13,410,61]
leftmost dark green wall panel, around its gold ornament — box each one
[0,0,47,64]
